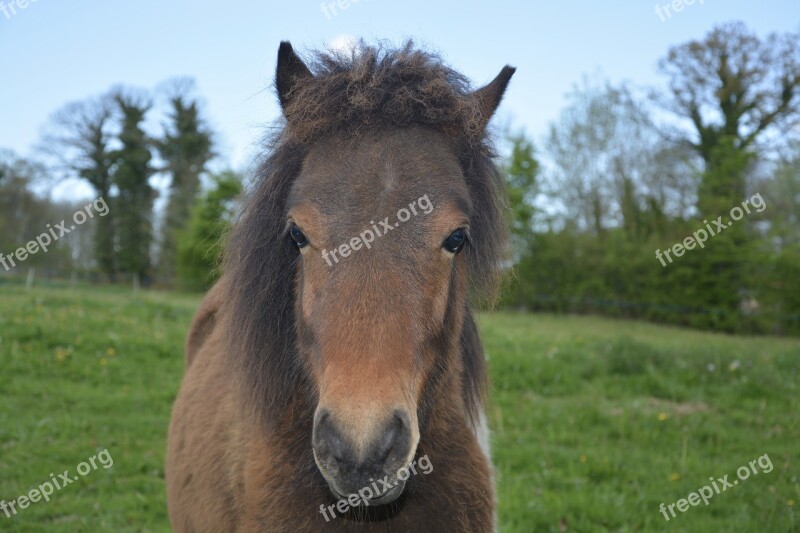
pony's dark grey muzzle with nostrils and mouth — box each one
[313,408,416,505]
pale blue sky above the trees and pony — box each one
[0,0,800,198]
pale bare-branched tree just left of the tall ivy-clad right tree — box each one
[545,80,687,236]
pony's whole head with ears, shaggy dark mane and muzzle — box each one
[227,42,514,503]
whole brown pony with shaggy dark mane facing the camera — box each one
[166,42,514,532]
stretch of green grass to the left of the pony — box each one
[0,287,194,531]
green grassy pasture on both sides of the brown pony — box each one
[0,285,800,533]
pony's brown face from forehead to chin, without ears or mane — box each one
[286,127,472,503]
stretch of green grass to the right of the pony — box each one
[480,314,800,532]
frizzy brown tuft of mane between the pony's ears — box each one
[285,41,490,150]
